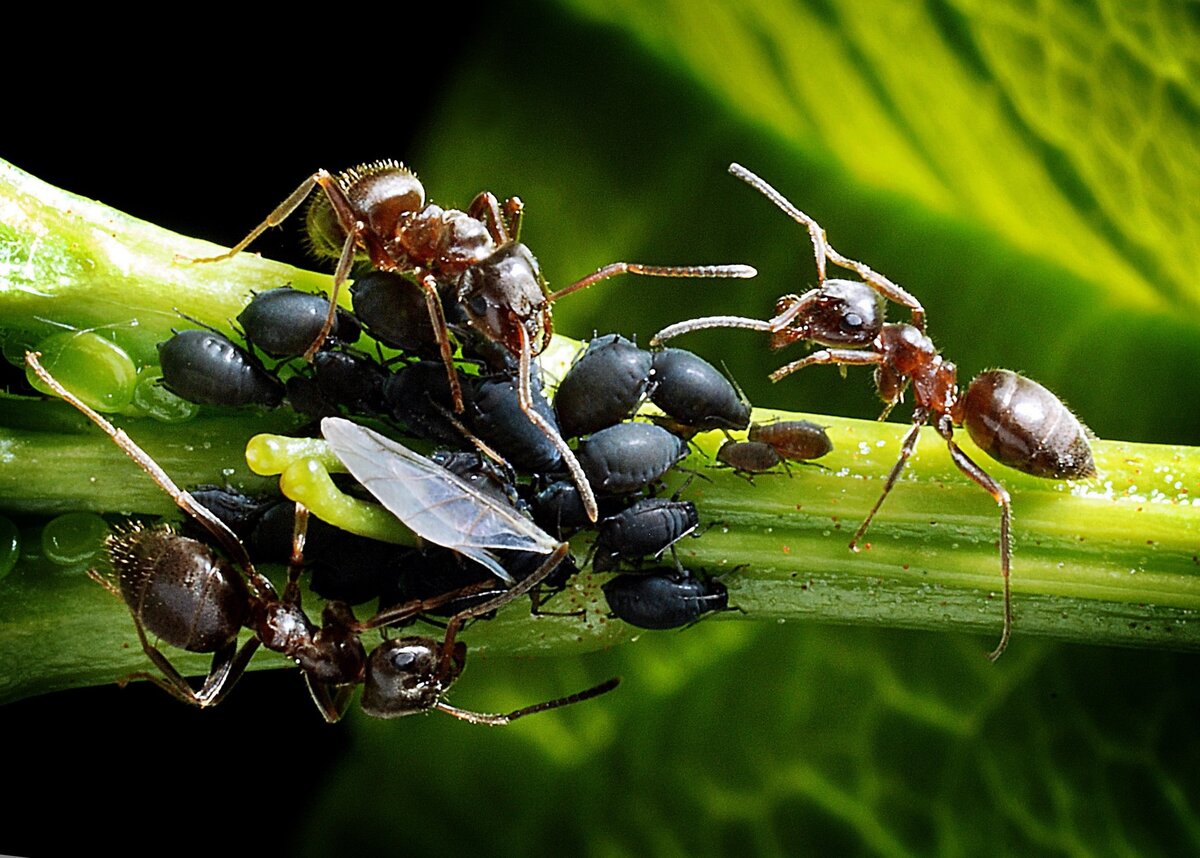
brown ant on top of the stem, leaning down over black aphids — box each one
[194,161,756,521]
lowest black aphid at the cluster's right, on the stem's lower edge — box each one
[600,569,736,629]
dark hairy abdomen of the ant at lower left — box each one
[108,524,248,653]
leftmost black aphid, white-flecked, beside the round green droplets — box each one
[158,330,284,408]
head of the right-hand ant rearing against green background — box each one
[770,280,884,348]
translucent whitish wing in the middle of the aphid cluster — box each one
[320,418,559,582]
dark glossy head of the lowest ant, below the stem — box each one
[362,637,467,718]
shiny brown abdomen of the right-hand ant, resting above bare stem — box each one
[953,370,1096,480]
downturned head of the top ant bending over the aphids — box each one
[458,241,552,355]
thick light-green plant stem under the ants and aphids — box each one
[0,157,1200,701]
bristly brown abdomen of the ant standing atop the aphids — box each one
[305,161,425,259]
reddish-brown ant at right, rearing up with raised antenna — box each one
[652,164,1096,661]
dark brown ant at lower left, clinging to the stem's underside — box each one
[25,352,619,725]
